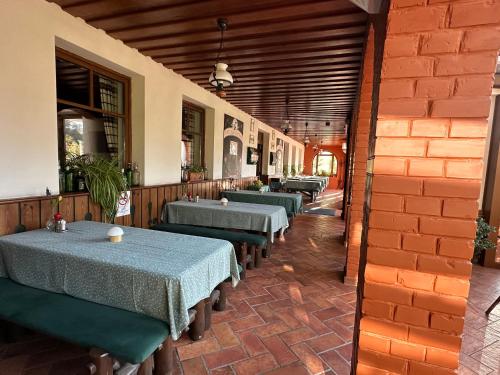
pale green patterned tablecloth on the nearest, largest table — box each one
[0,221,239,340]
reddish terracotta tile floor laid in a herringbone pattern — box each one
[0,192,500,375]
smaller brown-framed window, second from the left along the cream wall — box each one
[181,102,205,167]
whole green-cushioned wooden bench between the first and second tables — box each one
[151,223,267,279]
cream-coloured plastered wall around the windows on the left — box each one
[0,0,301,198]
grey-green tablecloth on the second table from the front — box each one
[167,199,288,233]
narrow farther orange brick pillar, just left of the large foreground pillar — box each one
[344,28,374,284]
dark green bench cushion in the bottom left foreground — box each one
[0,277,169,364]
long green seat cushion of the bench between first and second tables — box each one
[151,223,267,247]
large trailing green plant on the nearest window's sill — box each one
[68,154,127,222]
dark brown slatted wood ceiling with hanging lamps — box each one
[51,0,367,144]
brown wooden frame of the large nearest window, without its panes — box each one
[54,47,132,167]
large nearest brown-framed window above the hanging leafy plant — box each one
[56,49,130,165]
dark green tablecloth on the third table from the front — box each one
[222,190,302,215]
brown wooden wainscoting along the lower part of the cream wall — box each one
[0,177,257,235]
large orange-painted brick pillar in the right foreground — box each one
[357,0,500,374]
